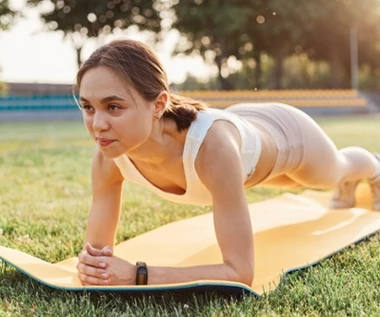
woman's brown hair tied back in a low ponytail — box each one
[76,40,207,131]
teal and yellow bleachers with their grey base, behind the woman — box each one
[0,89,368,122]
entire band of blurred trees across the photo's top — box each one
[8,0,380,89]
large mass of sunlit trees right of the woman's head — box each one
[172,0,380,89]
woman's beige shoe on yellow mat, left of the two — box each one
[330,180,360,209]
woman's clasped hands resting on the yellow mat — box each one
[77,243,136,285]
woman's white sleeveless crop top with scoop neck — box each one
[114,108,261,205]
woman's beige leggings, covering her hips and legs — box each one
[226,103,378,188]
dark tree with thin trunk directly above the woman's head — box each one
[28,0,161,67]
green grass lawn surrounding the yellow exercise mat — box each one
[0,117,380,317]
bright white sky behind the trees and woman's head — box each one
[0,0,213,84]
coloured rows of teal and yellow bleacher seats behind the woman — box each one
[0,89,367,113]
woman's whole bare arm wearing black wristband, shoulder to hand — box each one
[77,121,254,285]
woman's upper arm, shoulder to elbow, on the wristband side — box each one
[196,121,254,285]
